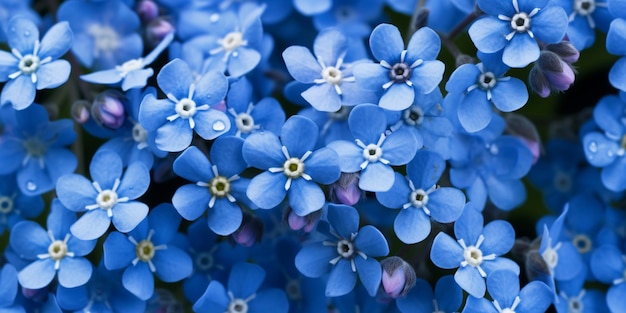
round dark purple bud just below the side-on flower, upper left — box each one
[91,90,128,129]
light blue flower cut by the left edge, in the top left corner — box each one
[0,16,74,110]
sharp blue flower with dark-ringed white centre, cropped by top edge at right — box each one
[468,0,568,68]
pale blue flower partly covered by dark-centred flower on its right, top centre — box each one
[282,27,376,112]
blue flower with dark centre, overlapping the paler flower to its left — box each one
[354,24,444,111]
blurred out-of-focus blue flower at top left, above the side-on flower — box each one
[57,0,143,70]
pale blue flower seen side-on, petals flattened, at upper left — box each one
[80,33,174,91]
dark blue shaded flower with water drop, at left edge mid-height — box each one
[0,104,77,196]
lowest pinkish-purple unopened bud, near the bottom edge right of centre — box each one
[380,256,416,298]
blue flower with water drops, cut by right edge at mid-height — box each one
[582,93,626,191]
